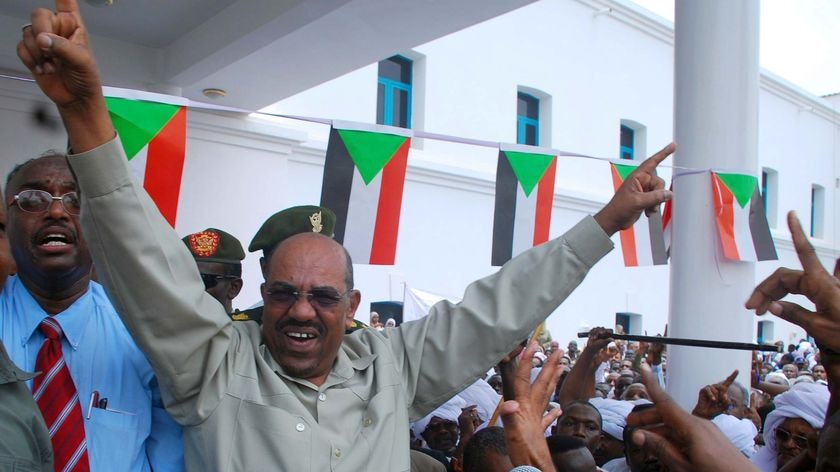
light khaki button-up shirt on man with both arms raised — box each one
[70,140,612,472]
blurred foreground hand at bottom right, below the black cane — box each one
[627,365,758,472]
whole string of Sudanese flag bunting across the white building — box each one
[88,87,778,267]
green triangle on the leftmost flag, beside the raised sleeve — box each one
[105,97,181,160]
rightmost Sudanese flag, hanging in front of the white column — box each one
[711,171,779,261]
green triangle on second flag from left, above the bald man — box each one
[338,129,408,185]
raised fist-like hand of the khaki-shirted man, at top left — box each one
[17,0,114,152]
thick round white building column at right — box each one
[667,0,759,410]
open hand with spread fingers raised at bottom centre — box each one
[501,343,562,472]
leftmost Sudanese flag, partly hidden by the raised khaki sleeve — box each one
[105,89,187,228]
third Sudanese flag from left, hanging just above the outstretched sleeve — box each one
[491,145,557,266]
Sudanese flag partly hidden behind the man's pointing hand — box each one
[610,162,670,267]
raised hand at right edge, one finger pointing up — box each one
[746,212,840,352]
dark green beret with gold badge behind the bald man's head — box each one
[248,205,335,252]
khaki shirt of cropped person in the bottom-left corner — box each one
[0,342,53,472]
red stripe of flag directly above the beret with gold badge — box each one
[370,138,411,265]
